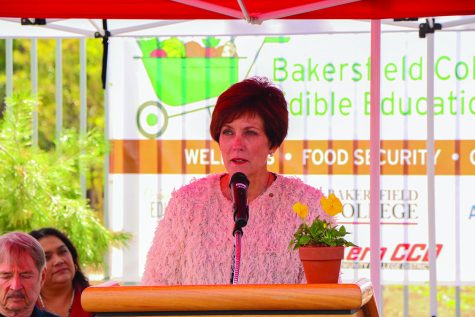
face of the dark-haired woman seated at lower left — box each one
[39,236,76,287]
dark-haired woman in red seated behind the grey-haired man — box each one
[30,228,93,317]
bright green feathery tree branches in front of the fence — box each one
[0,98,129,266]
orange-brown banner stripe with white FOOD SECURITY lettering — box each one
[110,140,475,175]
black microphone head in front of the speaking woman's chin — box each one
[229,172,249,236]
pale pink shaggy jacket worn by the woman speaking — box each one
[142,174,329,285]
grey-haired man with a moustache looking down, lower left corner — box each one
[0,232,57,317]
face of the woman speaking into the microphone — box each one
[219,115,270,178]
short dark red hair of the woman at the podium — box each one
[210,77,289,148]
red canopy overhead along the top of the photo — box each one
[0,0,475,20]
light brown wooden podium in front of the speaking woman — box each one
[81,279,379,317]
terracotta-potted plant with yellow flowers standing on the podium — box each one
[289,194,354,283]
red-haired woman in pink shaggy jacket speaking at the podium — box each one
[142,77,331,285]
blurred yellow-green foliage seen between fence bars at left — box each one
[0,39,104,211]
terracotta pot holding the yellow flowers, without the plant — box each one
[299,246,344,284]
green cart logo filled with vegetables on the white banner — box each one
[136,37,289,139]
